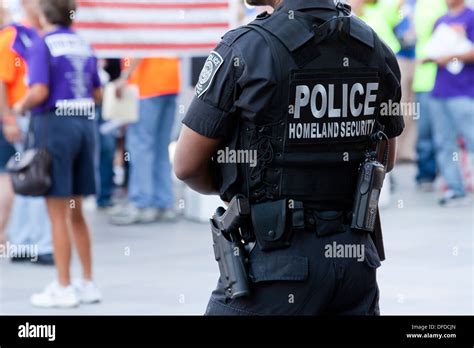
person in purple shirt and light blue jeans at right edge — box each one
[432,0,474,207]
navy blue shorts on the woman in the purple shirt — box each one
[32,113,96,198]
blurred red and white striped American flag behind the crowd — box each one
[75,0,237,58]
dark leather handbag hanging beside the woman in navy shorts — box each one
[6,120,52,197]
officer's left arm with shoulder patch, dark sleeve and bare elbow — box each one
[174,40,245,194]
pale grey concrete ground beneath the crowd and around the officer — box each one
[0,165,474,315]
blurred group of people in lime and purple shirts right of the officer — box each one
[350,0,474,206]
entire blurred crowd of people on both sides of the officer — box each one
[0,0,474,306]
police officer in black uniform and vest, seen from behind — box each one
[175,0,404,315]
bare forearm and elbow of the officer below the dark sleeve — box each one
[174,125,220,194]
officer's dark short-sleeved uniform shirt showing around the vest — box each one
[183,0,404,139]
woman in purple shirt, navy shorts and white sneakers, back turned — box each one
[14,0,101,307]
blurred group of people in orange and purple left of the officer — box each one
[0,0,181,307]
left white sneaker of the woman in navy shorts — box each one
[30,282,79,308]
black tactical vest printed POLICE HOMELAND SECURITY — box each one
[219,3,393,210]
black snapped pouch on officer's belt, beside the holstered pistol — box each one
[251,199,292,251]
